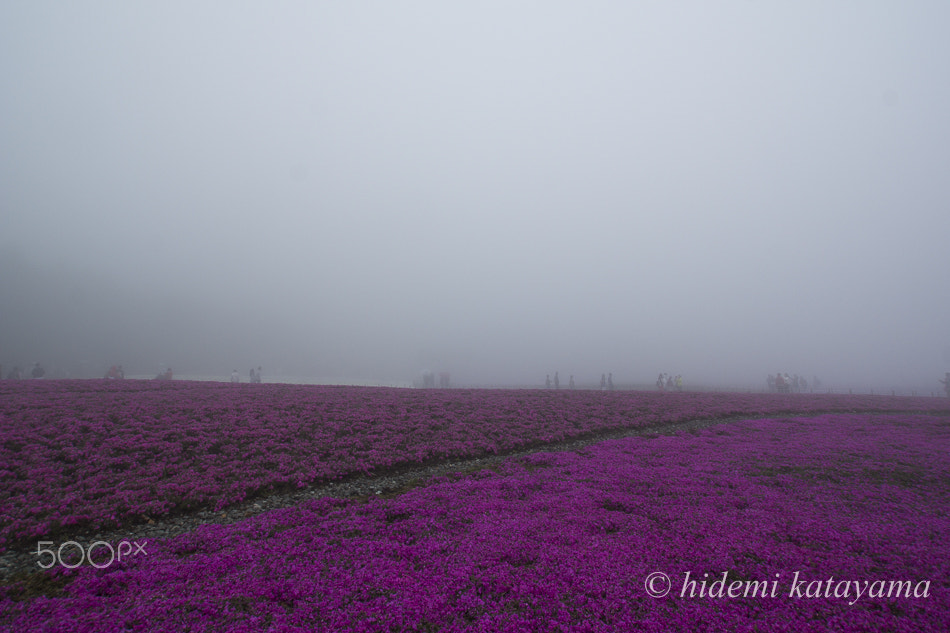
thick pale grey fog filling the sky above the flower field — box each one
[0,1,950,391]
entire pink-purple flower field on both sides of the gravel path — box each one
[0,381,950,631]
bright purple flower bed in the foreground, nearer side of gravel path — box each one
[0,412,950,631]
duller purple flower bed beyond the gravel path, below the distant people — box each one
[0,380,948,551]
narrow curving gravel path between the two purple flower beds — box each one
[0,410,950,599]
